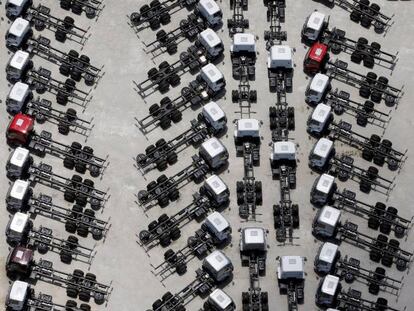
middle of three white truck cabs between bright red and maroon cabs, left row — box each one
[6,179,32,213]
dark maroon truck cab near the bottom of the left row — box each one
[6,246,34,278]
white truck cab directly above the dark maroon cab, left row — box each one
[6,212,33,246]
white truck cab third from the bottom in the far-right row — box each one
[312,205,341,238]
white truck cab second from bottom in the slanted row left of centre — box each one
[202,250,234,283]
